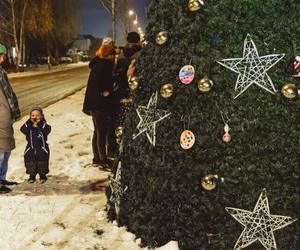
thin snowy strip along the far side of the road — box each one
[8,62,89,79]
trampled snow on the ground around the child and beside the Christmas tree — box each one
[0,90,179,250]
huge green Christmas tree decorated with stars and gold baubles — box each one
[110,0,300,250]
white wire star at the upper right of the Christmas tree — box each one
[218,34,284,98]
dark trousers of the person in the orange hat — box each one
[92,111,117,162]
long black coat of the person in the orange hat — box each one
[83,56,116,115]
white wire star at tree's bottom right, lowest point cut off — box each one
[225,189,297,250]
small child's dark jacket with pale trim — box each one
[21,120,51,163]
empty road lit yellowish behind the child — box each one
[10,66,89,116]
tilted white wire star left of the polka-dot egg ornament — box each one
[132,91,171,146]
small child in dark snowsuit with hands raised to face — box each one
[21,107,51,183]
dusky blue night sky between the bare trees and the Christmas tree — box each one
[80,0,151,42]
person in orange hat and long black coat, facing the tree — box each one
[83,44,117,167]
